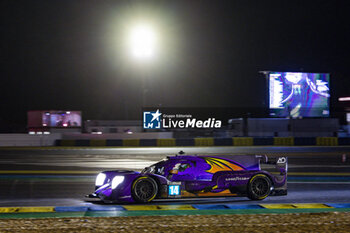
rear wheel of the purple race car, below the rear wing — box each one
[248,174,271,200]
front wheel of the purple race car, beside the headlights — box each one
[131,176,158,203]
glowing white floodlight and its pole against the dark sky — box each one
[129,24,157,107]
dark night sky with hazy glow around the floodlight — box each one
[0,0,350,132]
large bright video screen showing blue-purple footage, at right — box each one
[268,72,330,118]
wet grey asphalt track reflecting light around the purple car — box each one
[0,147,350,206]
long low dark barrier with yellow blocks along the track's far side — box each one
[56,137,350,147]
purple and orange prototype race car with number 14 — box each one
[88,152,288,203]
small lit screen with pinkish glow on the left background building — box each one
[42,111,81,128]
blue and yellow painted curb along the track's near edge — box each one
[0,203,350,219]
